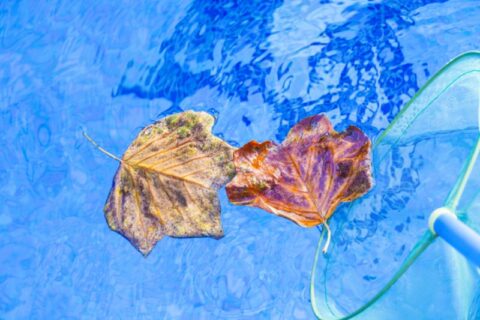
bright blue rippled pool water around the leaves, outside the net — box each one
[0,0,480,319]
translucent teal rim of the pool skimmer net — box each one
[310,52,480,319]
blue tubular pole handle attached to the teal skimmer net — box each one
[428,208,480,267]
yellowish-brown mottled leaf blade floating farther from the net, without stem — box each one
[87,111,235,255]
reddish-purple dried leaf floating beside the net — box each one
[227,115,372,250]
